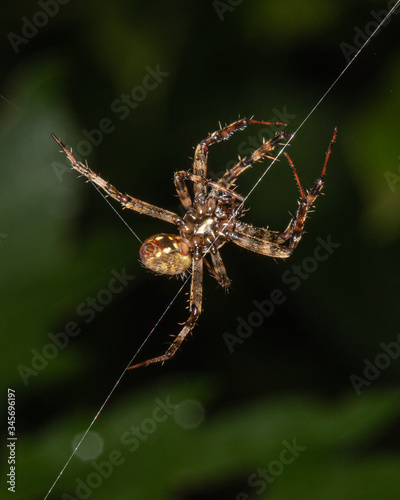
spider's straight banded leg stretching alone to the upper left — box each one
[51,134,180,224]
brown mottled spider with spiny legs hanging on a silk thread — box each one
[52,118,337,369]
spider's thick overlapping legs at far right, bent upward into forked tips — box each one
[229,128,337,259]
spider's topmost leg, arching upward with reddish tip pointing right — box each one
[193,118,286,197]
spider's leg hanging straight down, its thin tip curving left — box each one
[128,256,203,370]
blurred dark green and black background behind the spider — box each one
[0,0,400,500]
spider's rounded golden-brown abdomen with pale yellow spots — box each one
[139,233,192,275]
